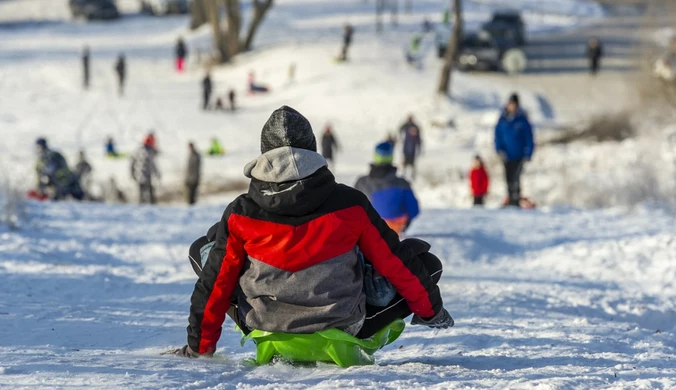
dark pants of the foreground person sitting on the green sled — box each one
[188,237,443,339]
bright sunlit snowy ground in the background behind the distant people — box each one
[0,0,603,206]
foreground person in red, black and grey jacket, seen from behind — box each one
[175,106,453,357]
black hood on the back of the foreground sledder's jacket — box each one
[249,167,336,217]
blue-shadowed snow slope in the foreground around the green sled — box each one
[0,204,676,389]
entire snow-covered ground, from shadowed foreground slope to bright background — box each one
[0,0,676,389]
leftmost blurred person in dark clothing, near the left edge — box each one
[35,138,84,200]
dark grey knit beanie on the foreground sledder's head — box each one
[261,106,317,153]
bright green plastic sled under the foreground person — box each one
[241,320,406,367]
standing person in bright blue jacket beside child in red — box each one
[495,94,534,207]
